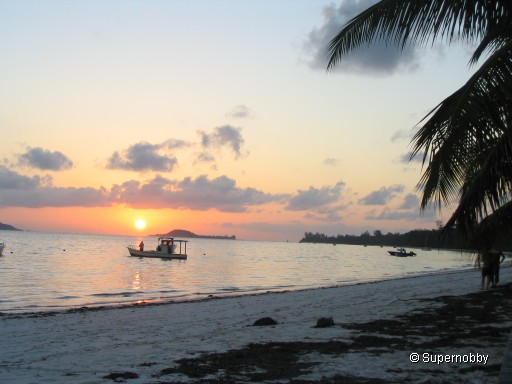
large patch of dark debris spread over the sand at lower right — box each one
[106,286,512,384]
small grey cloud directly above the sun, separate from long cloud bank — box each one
[107,141,178,172]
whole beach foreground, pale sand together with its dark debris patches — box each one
[0,267,512,384]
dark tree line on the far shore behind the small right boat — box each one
[300,228,512,251]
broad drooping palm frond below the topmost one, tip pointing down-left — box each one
[412,41,512,208]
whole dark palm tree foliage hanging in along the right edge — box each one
[327,0,512,248]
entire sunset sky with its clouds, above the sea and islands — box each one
[0,0,480,241]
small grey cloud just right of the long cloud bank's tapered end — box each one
[286,181,345,211]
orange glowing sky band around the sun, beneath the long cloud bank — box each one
[0,205,332,241]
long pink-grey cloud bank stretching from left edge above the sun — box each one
[0,165,282,212]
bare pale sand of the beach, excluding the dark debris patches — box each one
[0,268,512,384]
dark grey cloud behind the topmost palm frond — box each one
[304,0,418,75]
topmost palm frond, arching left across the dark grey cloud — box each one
[327,0,512,70]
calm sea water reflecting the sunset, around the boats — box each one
[0,231,473,313]
